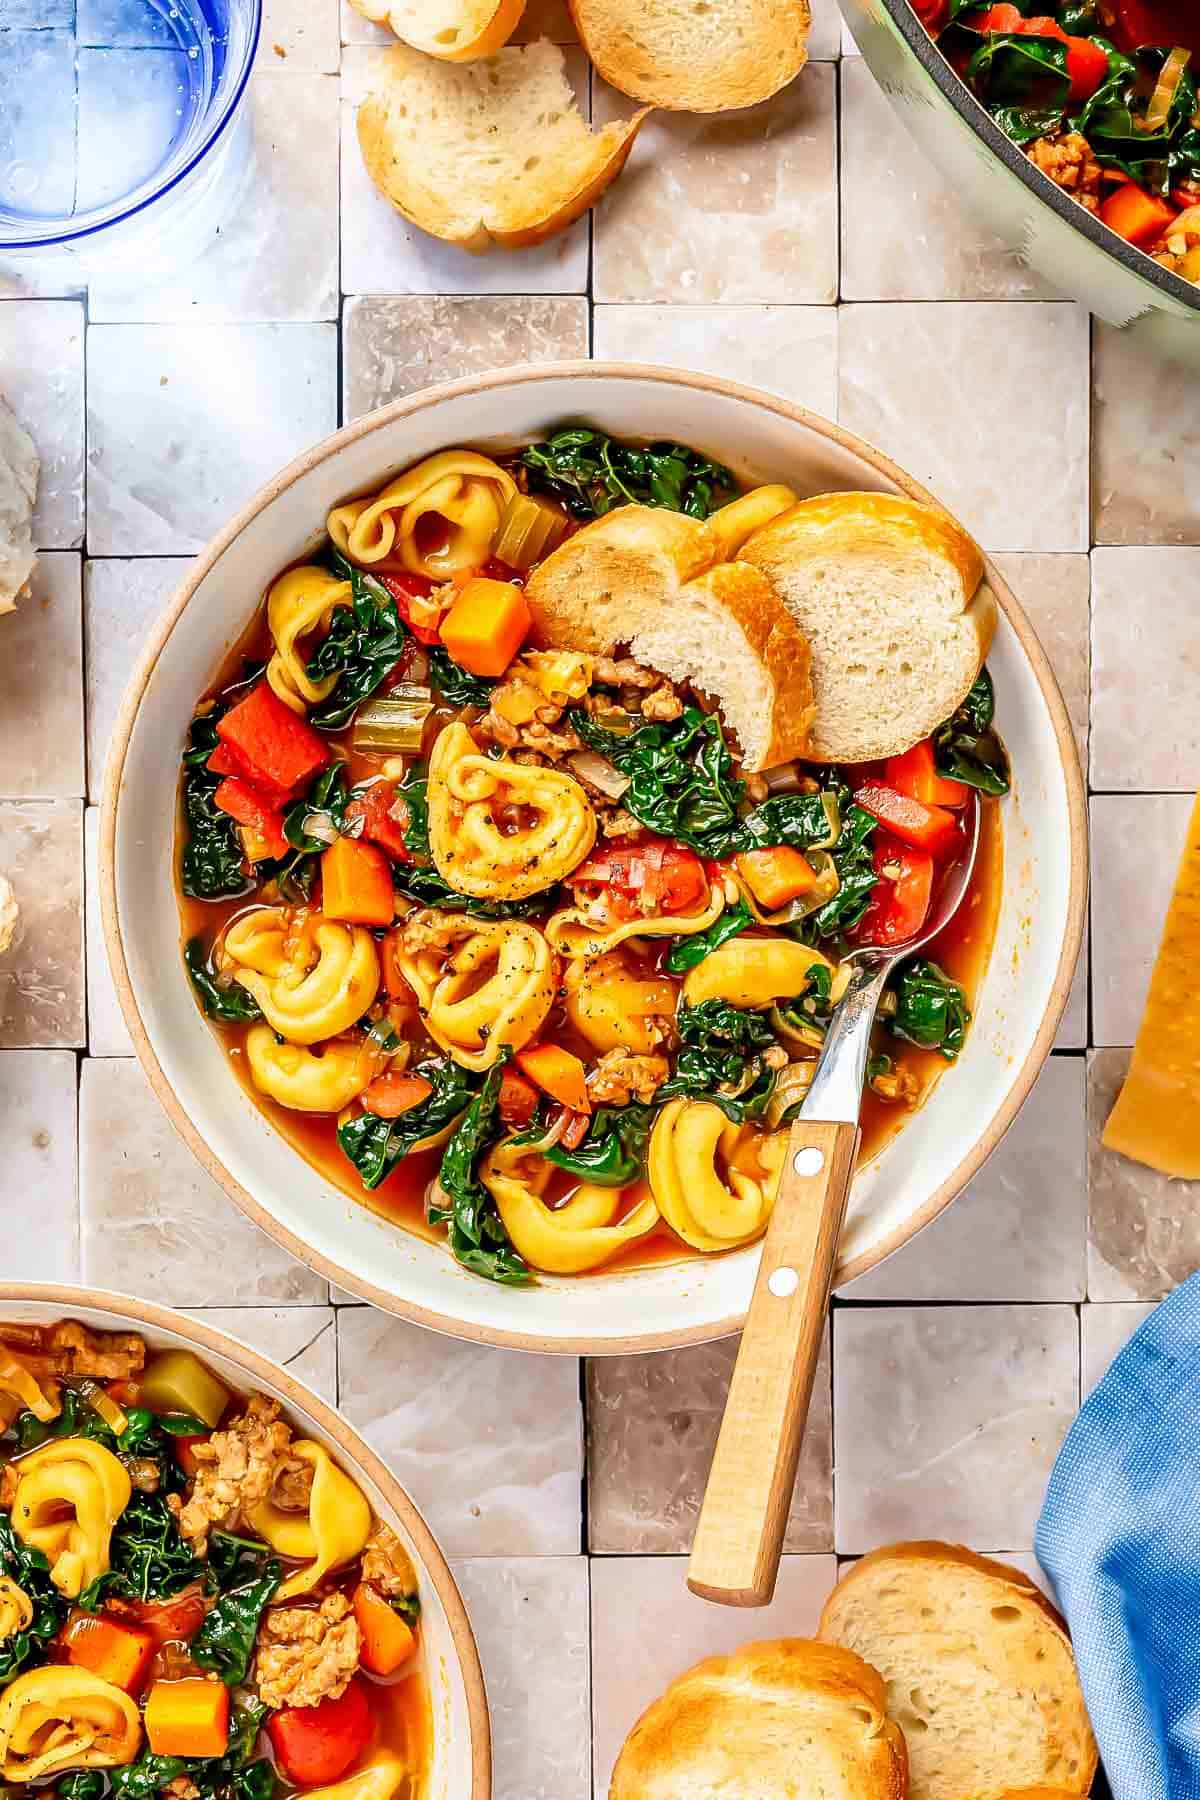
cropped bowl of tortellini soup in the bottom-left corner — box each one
[0,1283,491,1800]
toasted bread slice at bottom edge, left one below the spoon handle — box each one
[608,1638,907,1800]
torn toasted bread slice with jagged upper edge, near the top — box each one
[358,40,646,250]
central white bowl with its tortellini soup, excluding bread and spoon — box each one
[101,364,1085,1354]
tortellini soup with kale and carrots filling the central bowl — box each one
[176,427,1007,1288]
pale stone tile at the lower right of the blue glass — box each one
[88,72,338,322]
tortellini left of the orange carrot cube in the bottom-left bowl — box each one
[0,1663,142,1782]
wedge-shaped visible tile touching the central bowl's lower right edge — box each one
[844,1057,1087,1300]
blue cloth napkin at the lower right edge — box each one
[1036,1274,1200,1800]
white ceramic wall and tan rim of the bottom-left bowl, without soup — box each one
[0,1282,491,1800]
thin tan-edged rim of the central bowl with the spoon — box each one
[96,360,1088,1355]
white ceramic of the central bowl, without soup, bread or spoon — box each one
[101,364,1085,1354]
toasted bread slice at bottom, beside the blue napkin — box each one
[819,1543,1096,1800]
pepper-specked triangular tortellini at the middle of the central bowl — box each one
[428,722,596,900]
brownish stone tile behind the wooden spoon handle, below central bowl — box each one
[587,1337,833,1553]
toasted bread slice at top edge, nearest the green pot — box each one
[569,0,810,112]
